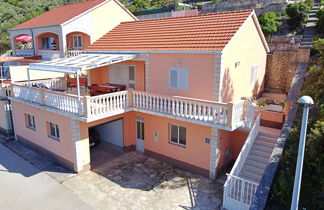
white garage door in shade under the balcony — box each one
[95,119,124,148]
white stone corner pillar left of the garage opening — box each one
[71,119,83,172]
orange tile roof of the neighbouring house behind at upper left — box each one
[11,0,105,30]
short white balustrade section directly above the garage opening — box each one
[86,91,129,117]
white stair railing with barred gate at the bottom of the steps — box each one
[223,114,260,209]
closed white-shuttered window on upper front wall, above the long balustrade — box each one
[169,67,189,90]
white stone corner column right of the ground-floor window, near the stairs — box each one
[209,128,220,179]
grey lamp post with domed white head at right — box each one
[291,96,314,210]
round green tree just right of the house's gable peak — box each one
[258,12,281,36]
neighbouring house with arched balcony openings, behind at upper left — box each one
[9,0,137,60]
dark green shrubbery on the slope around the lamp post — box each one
[265,39,324,209]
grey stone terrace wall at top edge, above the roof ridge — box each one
[201,0,285,15]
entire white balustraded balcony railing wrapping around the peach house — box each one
[11,79,246,130]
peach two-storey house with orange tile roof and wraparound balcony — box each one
[10,10,269,209]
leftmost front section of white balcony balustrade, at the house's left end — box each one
[12,84,42,104]
